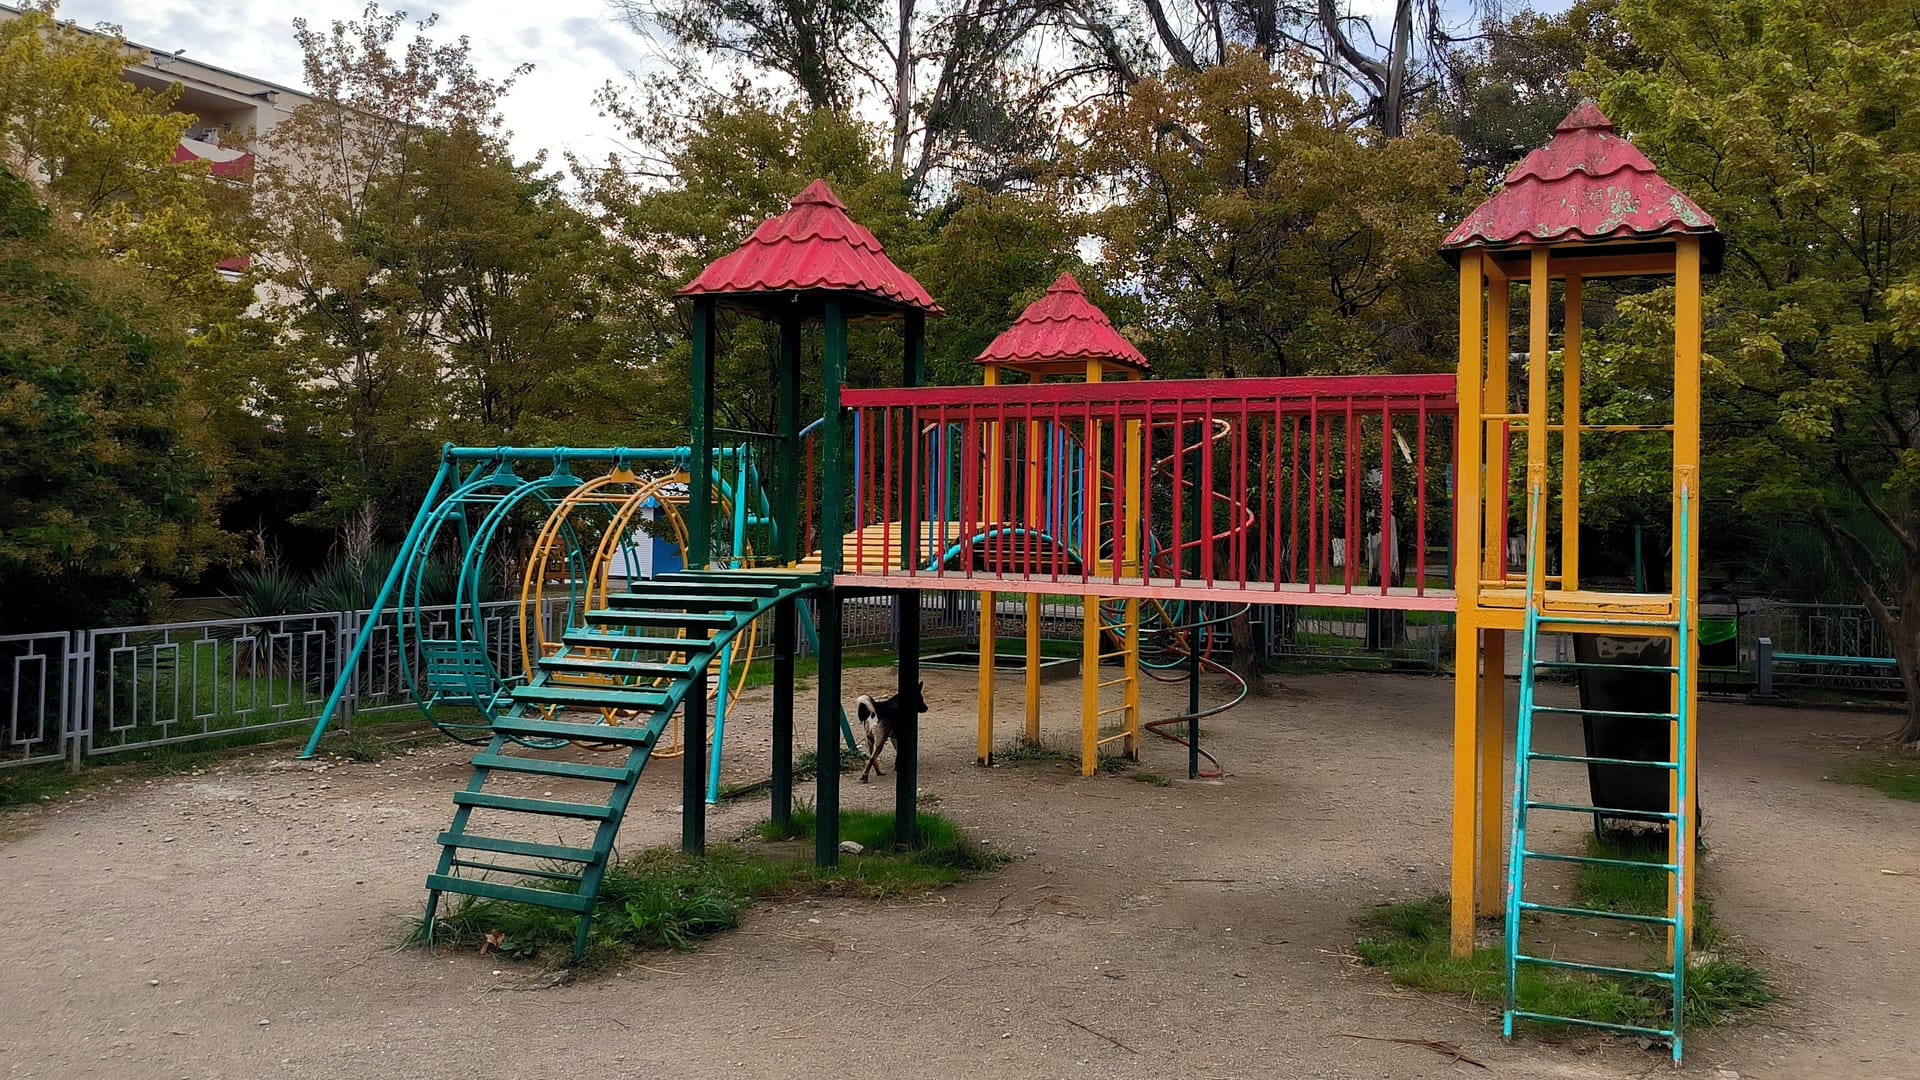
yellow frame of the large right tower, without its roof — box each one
[1452,234,1711,955]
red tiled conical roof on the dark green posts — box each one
[680,181,941,315]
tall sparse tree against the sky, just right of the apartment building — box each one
[248,4,520,525]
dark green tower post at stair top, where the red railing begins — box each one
[814,298,847,867]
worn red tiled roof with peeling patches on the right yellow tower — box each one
[1442,102,1716,252]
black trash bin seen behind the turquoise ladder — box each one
[1572,634,1672,836]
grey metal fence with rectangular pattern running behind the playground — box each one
[0,592,1899,769]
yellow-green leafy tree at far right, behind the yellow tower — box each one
[1592,0,1920,744]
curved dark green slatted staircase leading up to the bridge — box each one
[426,571,822,961]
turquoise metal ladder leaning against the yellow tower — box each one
[1501,486,1693,1065]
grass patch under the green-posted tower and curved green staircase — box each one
[422,805,1010,967]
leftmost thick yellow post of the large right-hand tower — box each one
[1450,252,1486,957]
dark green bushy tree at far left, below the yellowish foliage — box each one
[0,169,223,630]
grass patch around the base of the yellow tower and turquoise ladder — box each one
[1354,896,1774,1026]
